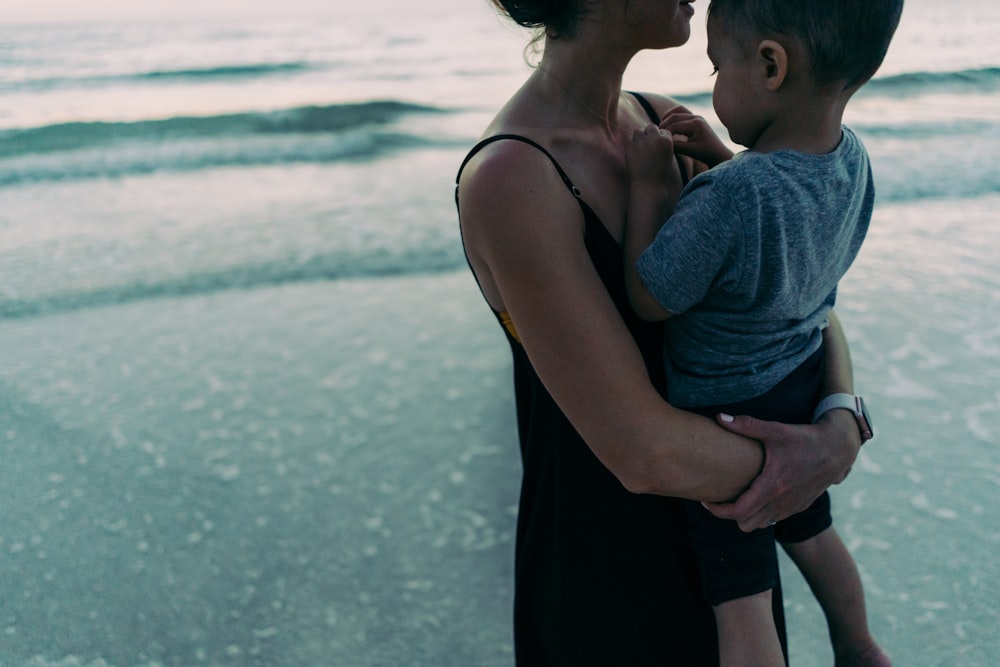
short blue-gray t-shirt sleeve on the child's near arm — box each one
[637,174,744,315]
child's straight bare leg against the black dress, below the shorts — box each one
[712,591,785,667]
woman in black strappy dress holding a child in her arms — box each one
[456,0,860,667]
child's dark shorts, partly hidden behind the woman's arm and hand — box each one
[684,347,833,605]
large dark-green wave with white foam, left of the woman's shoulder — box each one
[0,101,451,186]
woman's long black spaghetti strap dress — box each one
[456,96,784,667]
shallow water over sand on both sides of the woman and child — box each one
[0,194,1000,667]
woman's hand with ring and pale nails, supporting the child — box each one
[704,410,861,532]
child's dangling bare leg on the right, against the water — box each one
[781,527,890,667]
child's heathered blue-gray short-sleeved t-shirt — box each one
[638,127,875,408]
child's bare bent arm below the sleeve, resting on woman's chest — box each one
[623,125,683,321]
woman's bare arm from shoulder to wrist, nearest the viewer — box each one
[459,142,763,500]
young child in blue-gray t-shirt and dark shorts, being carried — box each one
[624,0,903,667]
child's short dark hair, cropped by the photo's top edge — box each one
[708,0,903,90]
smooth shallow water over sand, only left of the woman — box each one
[0,272,519,667]
